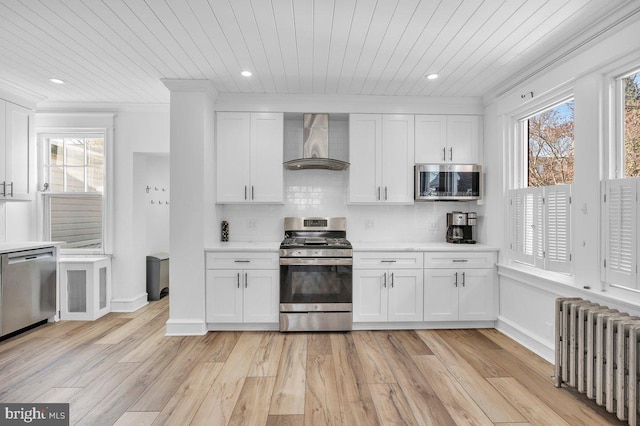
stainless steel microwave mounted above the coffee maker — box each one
[415,164,482,201]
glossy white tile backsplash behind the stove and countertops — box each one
[216,170,481,242]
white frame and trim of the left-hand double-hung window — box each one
[37,127,113,255]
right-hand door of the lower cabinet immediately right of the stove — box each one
[387,269,424,322]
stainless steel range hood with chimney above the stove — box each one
[284,114,349,170]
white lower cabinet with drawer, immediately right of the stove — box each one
[353,252,423,322]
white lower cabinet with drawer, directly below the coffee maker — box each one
[424,252,497,321]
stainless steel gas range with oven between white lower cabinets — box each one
[280,217,353,331]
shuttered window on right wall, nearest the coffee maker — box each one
[509,99,574,273]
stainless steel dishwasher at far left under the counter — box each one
[0,247,57,336]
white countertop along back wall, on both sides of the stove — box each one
[204,241,499,252]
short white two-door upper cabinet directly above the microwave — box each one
[415,115,480,164]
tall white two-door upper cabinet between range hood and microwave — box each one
[349,114,414,204]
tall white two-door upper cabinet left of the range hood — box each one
[216,112,284,203]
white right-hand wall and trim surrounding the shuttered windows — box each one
[483,13,640,360]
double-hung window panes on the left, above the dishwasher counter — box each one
[38,131,106,253]
